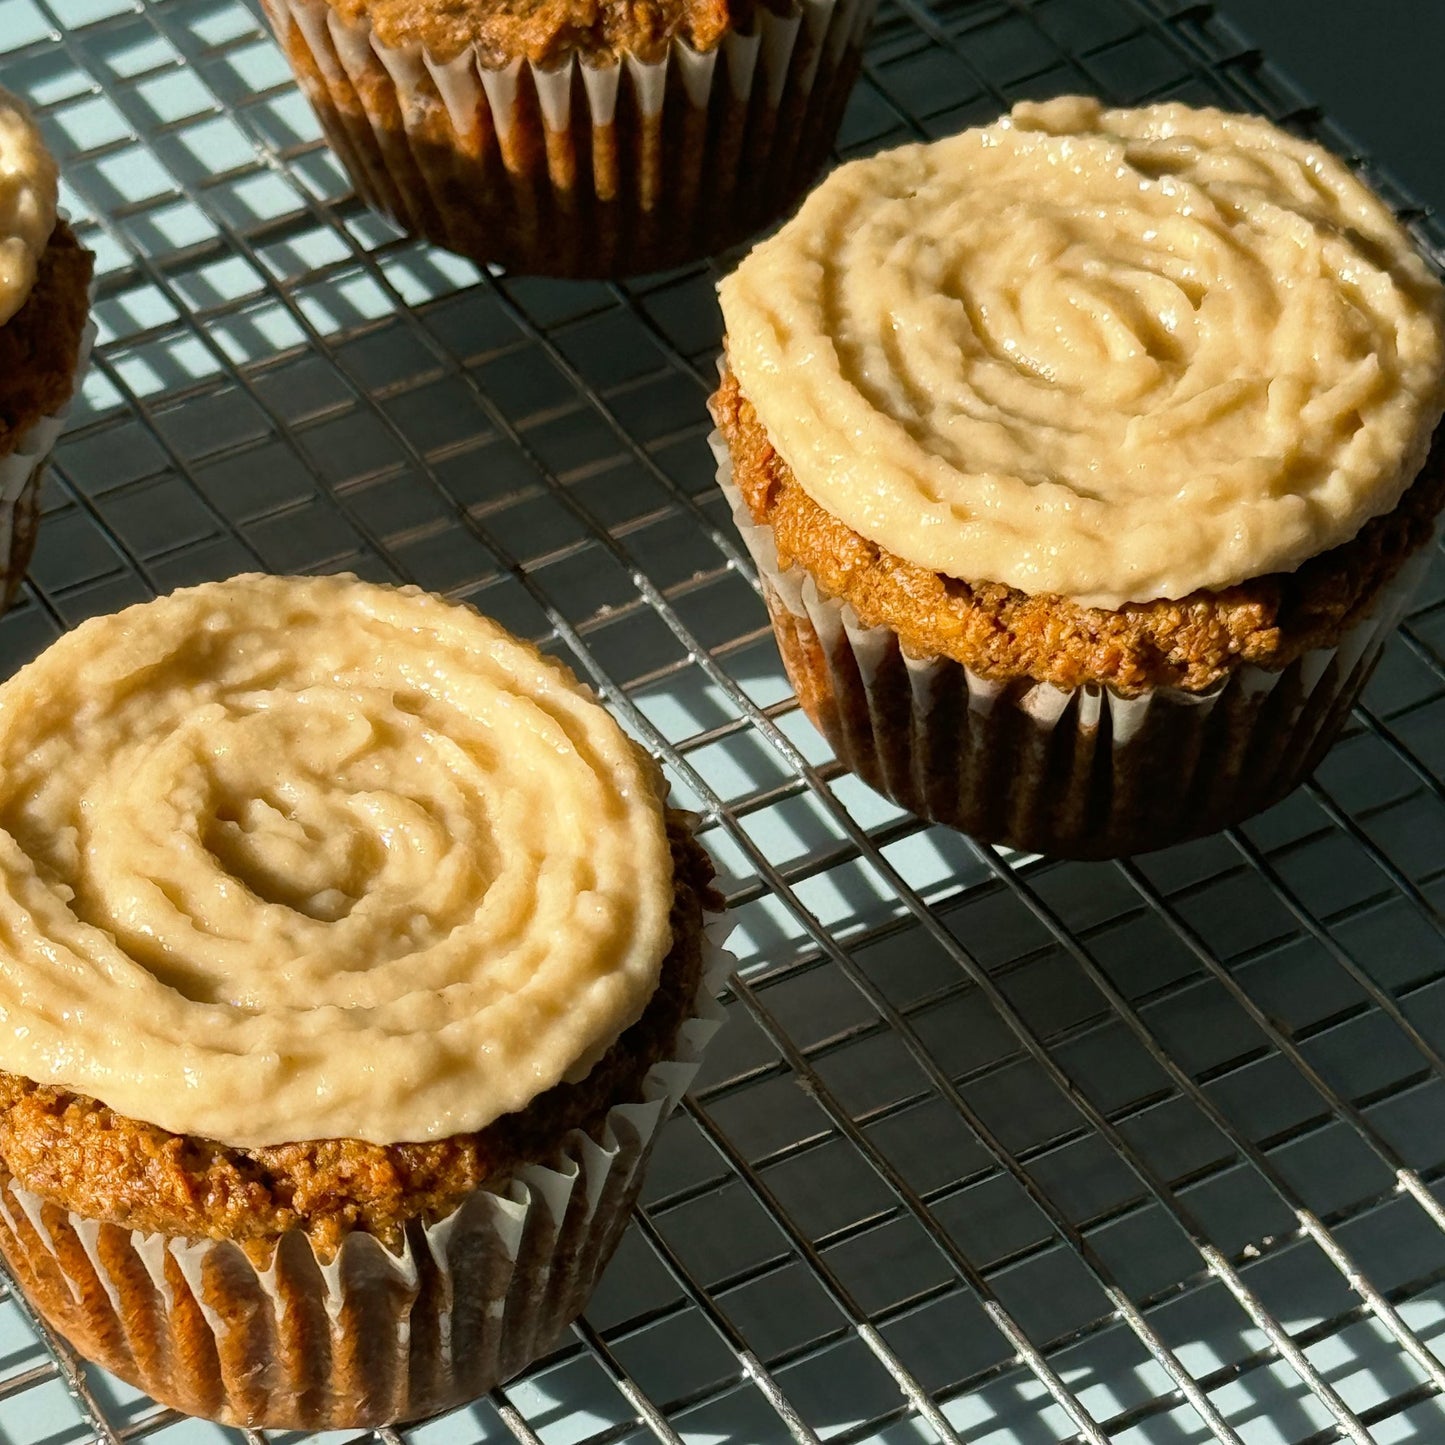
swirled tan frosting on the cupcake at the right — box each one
[720,97,1445,607]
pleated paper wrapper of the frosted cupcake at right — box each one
[709,432,1431,858]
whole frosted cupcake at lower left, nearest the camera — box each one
[0,577,721,1431]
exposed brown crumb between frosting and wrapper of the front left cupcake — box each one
[0,812,723,1259]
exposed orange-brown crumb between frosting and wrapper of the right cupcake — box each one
[711,374,1445,695]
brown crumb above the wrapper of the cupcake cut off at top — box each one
[327,0,754,68]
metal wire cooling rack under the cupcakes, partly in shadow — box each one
[0,0,1445,1445]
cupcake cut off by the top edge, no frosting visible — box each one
[254,0,876,276]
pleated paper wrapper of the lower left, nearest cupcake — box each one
[0,919,733,1429]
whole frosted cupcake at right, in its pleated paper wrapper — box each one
[712,97,1445,858]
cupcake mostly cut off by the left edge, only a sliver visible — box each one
[0,90,94,608]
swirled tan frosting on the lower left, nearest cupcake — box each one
[0,577,673,1147]
